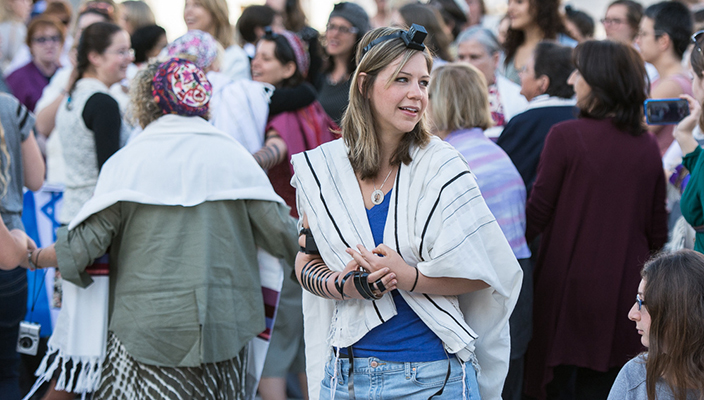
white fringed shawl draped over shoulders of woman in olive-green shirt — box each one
[25,115,285,399]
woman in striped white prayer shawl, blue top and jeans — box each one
[292,25,522,400]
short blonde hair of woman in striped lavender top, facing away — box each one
[428,63,493,133]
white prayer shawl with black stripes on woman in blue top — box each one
[292,137,522,399]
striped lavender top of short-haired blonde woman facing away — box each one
[445,128,530,259]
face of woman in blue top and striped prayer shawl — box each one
[360,52,430,136]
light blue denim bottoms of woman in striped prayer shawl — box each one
[320,356,481,400]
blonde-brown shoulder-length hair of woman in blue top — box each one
[340,28,433,180]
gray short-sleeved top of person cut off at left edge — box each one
[0,93,34,229]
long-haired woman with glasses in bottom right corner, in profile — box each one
[608,250,704,400]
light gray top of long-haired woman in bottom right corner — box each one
[607,355,699,400]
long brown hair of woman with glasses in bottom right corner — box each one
[642,250,704,400]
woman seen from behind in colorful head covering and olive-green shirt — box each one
[20,59,296,399]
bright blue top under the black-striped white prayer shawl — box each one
[343,191,447,362]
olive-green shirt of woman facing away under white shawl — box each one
[56,200,298,367]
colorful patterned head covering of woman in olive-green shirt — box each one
[152,58,213,117]
